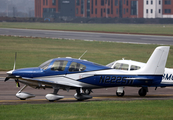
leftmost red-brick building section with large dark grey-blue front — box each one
[35,0,75,18]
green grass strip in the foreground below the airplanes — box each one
[0,100,173,120]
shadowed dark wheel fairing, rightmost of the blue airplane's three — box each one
[74,88,92,101]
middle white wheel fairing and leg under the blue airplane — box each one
[45,89,64,102]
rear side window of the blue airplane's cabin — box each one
[68,62,86,72]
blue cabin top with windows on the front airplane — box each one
[39,58,109,72]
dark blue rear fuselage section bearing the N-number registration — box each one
[79,75,162,87]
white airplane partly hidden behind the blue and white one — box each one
[106,52,173,97]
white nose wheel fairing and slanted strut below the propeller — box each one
[16,85,35,100]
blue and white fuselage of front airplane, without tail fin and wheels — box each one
[12,58,162,89]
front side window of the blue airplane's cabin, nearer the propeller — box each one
[51,60,68,71]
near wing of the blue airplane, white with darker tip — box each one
[22,77,82,88]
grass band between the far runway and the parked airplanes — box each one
[0,36,173,71]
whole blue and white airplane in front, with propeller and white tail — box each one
[4,46,170,102]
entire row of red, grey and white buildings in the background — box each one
[35,0,173,18]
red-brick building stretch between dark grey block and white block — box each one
[76,0,143,18]
